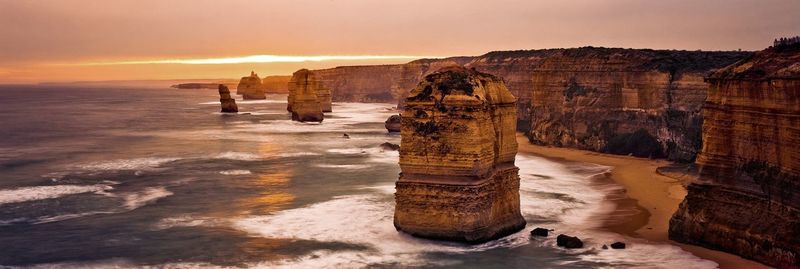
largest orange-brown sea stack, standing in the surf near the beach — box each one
[394,67,525,243]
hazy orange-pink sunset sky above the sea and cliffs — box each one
[0,0,800,83]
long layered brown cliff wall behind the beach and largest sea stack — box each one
[315,47,751,161]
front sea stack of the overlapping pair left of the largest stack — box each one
[286,69,324,122]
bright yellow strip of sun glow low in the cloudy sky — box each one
[69,55,442,66]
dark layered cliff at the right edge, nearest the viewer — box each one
[669,45,800,268]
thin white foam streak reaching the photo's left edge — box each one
[0,184,113,205]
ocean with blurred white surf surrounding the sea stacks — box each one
[0,86,717,268]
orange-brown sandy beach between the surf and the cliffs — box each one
[517,133,770,269]
